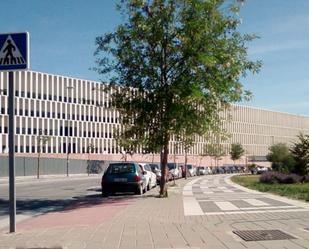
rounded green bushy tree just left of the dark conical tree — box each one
[266,143,295,173]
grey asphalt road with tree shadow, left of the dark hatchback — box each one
[0,176,101,221]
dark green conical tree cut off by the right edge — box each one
[290,134,309,175]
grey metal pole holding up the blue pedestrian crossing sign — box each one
[8,72,16,233]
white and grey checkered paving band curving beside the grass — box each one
[183,176,309,216]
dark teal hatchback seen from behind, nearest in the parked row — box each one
[101,162,147,196]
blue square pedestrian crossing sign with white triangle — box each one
[0,32,30,71]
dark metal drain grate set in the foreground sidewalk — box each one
[233,230,296,241]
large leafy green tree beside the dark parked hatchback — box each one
[95,0,261,195]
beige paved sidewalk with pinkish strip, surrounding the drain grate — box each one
[0,176,309,249]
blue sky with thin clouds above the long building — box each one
[0,0,309,116]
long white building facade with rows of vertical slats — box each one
[0,71,309,166]
